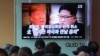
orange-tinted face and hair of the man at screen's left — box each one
[30,4,46,25]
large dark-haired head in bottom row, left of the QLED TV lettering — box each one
[44,42,61,56]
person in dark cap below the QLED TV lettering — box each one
[73,46,90,56]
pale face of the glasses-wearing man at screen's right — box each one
[59,10,76,25]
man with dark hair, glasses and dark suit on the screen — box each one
[58,3,85,38]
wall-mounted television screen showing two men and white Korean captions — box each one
[22,3,86,39]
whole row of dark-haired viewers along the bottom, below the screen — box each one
[0,39,99,56]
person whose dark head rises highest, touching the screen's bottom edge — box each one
[32,39,45,56]
